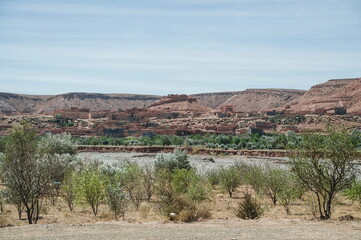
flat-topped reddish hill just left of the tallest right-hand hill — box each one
[222,89,305,112]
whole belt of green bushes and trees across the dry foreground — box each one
[0,125,361,226]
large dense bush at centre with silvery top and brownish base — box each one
[155,152,211,222]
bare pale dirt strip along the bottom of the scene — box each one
[0,219,361,240]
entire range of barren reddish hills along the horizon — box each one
[0,78,361,114]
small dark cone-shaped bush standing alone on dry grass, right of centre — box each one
[234,192,264,219]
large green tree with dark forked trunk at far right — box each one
[291,129,357,219]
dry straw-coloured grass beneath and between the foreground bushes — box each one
[0,186,361,226]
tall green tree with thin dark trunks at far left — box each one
[0,123,71,224]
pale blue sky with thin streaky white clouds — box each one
[0,0,361,95]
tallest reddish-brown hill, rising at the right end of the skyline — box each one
[286,78,361,113]
